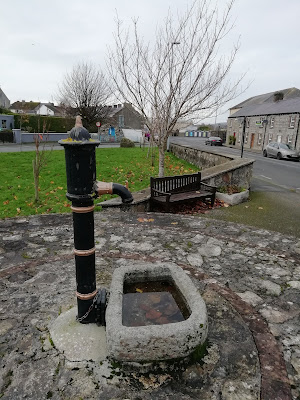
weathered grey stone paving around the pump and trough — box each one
[0,210,300,400]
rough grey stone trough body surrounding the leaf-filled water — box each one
[106,263,208,362]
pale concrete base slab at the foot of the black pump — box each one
[49,307,107,362]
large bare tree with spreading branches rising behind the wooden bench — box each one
[107,0,246,176]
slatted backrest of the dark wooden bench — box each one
[150,172,201,196]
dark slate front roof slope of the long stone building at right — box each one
[229,97,300,118]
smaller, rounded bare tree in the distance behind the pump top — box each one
[58,62,110,125]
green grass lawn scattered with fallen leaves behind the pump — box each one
[0,147,198,218]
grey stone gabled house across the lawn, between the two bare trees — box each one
[105,103,144,130]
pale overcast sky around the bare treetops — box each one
[0,0,300,122]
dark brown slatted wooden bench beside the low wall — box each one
[150,172,217,212]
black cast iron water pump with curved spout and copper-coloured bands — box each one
[59,117,133,325]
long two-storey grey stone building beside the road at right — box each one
[226,88,300,150]
